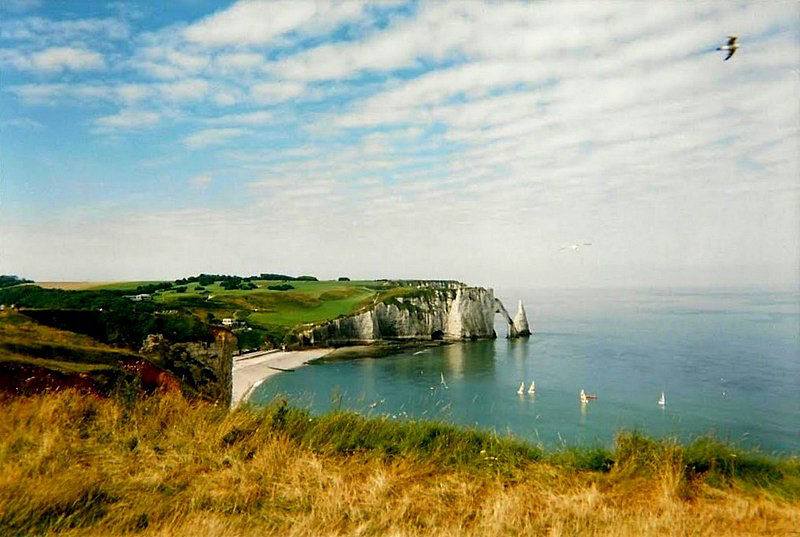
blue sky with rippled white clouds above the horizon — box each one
[0,0,800,288]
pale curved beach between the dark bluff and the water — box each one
[231,348,333,406]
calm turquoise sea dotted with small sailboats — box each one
[253,289,800,452]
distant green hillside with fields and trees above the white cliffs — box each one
[0,274,456,350]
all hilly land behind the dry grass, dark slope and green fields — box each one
[0,274,456,402]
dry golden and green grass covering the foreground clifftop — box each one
[0,391,800,536]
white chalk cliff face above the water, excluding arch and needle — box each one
[298,286,512,345]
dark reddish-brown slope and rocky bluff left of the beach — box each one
[0,309,230,402]
